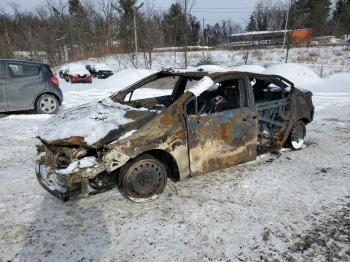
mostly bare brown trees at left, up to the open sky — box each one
[0,0,242,65]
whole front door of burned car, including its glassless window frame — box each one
[185,75,257,176]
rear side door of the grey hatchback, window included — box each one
[5,62,43,111]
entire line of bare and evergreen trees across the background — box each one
[0,0,350,65]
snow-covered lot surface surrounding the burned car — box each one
[0,64,350,261]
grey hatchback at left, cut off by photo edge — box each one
[0,59,63,114]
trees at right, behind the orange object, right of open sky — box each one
[246,0,350,36]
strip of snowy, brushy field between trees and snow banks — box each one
[78,46,350,77]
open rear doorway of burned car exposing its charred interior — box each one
[250,76,292,150]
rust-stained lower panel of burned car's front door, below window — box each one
[187,108,257,176]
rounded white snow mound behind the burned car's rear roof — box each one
[262,63,321,87]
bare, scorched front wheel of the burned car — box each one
[119,155,168,202]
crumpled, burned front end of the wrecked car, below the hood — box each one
[35,144,106,201]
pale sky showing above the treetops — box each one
[0,0,258,25]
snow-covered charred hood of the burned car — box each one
[39,99,156,148]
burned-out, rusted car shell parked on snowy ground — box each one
[36,70,314,200]
